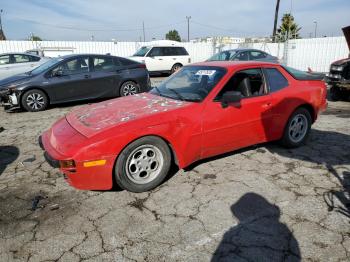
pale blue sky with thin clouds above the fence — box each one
[0,0,350,41]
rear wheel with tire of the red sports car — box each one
[281,107,312,148]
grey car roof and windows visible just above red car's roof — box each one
[207,48,279,63]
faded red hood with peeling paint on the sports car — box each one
[66,93,192,137]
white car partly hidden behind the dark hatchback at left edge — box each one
[0,53,50,80]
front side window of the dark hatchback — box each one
[51,57,89,75]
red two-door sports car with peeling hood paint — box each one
[39,62,327,192]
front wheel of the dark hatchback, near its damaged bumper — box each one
[21,89,49,112]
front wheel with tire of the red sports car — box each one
[114,136,171,193]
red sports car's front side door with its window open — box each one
[201,68,272,158]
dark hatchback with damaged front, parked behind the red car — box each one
[0,54,150,112]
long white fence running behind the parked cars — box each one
[0,37,349,72]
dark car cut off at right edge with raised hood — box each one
[327,26,350,100]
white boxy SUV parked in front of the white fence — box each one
[129,46,191,73]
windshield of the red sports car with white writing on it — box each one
[150,66,226,102]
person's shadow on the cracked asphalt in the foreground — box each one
[211,193,301,262]
